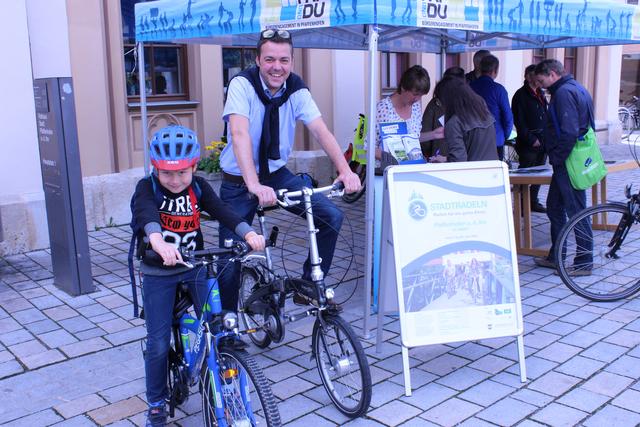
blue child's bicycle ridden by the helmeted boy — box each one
[145,242,281,427]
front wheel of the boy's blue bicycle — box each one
[200,347,282,427]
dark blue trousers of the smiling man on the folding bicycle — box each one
[218,167,343,311]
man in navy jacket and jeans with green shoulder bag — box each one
[535,59,595,276]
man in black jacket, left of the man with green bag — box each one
[511,64,547,213]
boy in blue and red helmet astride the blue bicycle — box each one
[132,126,265,426]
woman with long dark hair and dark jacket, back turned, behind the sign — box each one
[434,77,498,162]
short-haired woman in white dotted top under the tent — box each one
[376,65,443,173]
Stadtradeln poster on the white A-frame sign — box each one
[394,169,517,342]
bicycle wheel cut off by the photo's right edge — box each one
[555,203,640,301]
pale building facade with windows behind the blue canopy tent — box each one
[0,0,622,255]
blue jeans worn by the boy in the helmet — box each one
[142,268,207,404]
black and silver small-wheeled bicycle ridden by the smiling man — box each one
[239,183,371,418]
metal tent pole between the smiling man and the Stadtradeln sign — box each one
[362,25,382,339]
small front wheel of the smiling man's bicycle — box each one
[312,314,371,418]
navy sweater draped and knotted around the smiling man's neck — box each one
[237,66,307,182]
